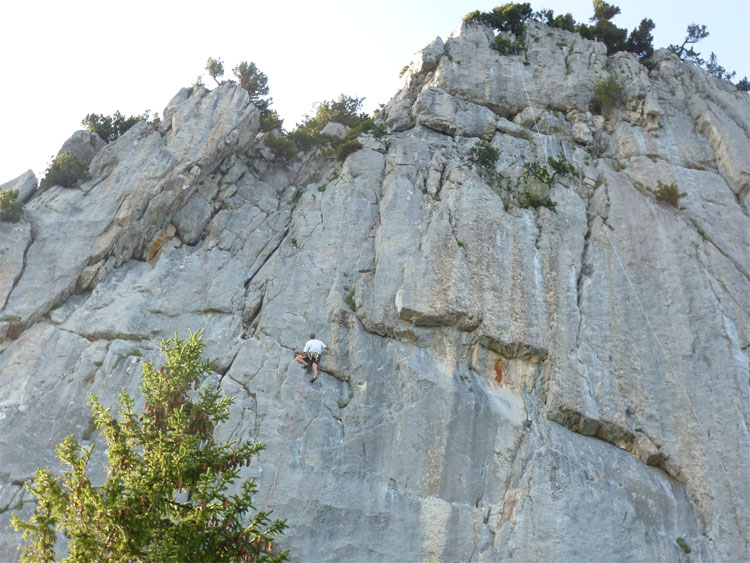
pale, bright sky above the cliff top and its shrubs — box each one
[0,0,750,183]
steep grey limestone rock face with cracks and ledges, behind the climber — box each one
[0,17,750,561]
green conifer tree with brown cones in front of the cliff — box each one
[11,333,287,561]
